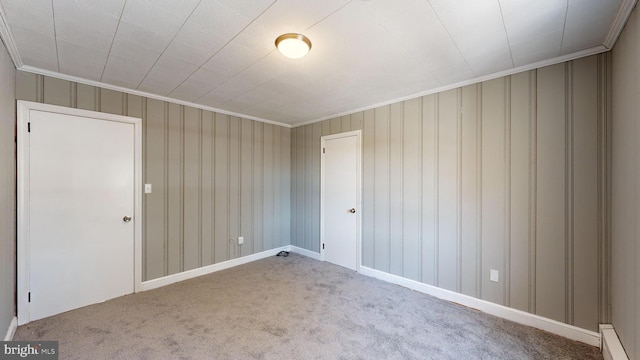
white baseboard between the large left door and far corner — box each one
[140,246,290,291]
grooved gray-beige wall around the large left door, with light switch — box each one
[12,71,291,280]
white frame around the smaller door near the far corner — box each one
[319,130,362,272]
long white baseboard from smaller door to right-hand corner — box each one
[360,266,600,346]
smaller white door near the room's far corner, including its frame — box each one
[321,131,360,270]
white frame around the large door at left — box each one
[16,100,142,325]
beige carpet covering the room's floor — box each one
[14,254,602,359]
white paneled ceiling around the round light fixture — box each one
[0,0,636,125]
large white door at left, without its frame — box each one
[18,104,135,323]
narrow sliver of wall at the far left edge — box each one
[0,35,16,340]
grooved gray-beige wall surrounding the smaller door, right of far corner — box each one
[291,55,610,331]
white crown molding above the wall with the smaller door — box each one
[291,45,609,128]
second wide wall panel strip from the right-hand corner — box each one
[536,64,568,322]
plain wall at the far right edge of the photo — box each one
[611,2,640,360]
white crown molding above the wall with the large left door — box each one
[18,65,291,128]
